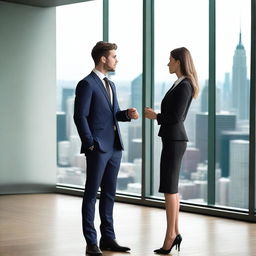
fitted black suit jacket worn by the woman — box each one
[157,78,193,141]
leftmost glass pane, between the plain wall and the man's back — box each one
[56,0,103,187]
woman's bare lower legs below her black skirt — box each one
[163,193,178,250]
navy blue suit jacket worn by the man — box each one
[74,71,130,153]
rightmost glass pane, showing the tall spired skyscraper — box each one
[216,0,251,209]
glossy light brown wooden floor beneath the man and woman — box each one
[0,194,256,256]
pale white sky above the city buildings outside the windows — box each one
[57,0,250,84]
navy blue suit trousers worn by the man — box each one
[82,143,122,244]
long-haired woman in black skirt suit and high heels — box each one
[144,47,199,254]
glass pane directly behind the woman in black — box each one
[153,0,209,204]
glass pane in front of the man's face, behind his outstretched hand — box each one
[109,0,143,194]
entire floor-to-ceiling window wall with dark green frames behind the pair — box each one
[57,0,256,218]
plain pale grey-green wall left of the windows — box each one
[0,1,56,194]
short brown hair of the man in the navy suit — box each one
[91,41,117,65]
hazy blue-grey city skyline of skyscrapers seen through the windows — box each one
[57,1,252,208]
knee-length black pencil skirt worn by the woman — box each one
[159,138,187,194]
